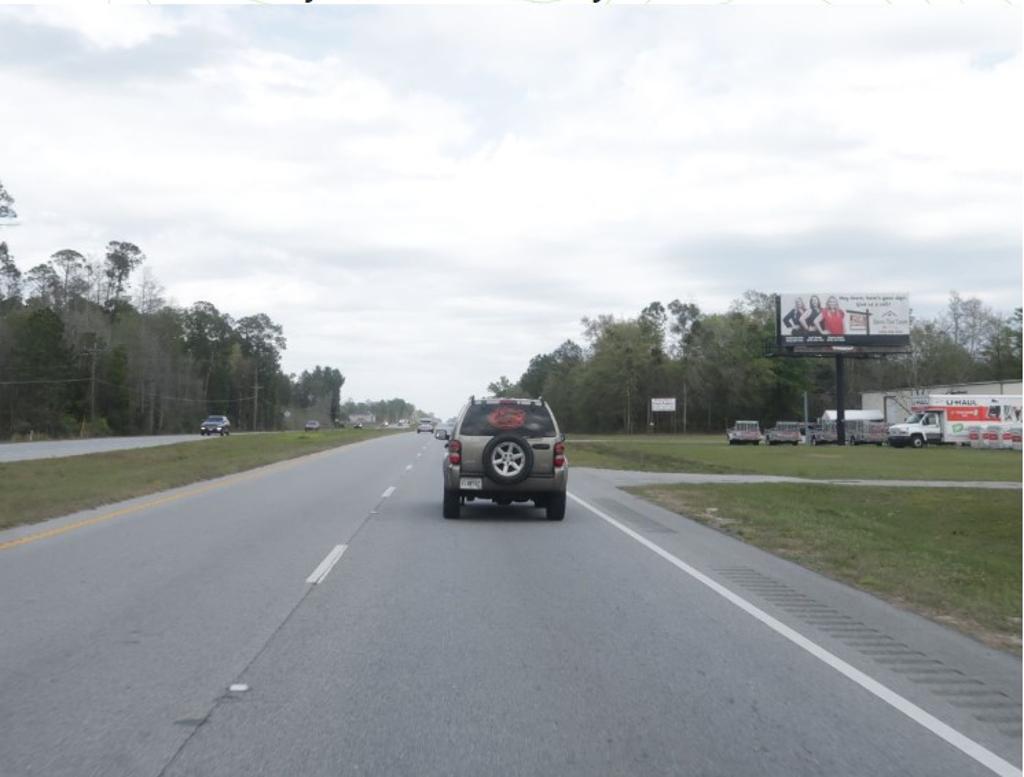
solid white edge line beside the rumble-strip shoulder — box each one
[568,493,1021,777]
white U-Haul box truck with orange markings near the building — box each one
[889,394,1021,447]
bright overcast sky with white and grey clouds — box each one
[0,3,1024,416]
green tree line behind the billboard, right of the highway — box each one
[488,291,1021,433]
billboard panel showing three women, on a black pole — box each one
[775,292,910,353]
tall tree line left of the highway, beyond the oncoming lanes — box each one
[0,183,428,439]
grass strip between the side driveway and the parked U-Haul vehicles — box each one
[567,434,1021,481]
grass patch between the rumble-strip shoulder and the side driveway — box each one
[629,483,1021,652]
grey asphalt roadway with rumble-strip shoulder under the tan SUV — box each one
[0,434,1021,777]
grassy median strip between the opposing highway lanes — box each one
[0,429,389,528]
